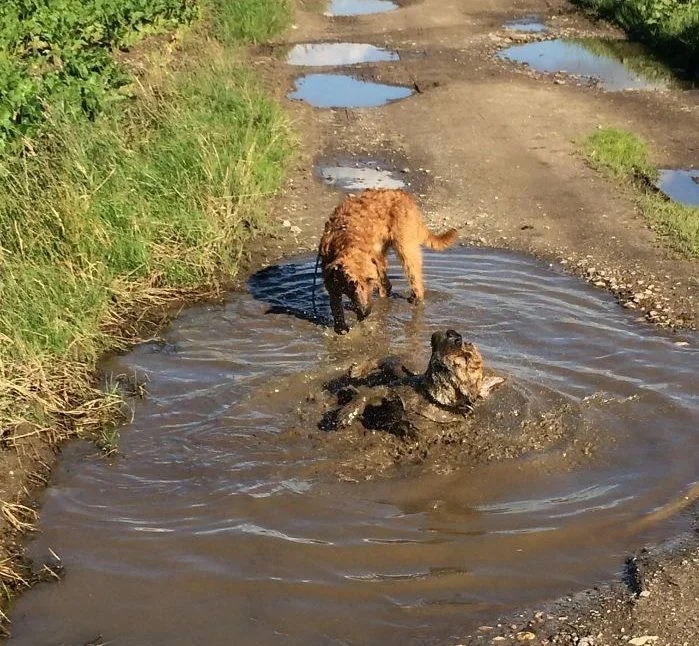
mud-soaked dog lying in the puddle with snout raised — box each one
[320,330,505,437]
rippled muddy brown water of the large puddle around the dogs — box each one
[10,248,699,646]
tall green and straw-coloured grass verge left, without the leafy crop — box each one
[0,0,294,436]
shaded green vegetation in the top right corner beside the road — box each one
[572,0,699,79]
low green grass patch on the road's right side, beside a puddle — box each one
[580,128,699,258]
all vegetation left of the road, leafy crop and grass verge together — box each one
[0,0,293,624]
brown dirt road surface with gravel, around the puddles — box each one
[257,0,699,646]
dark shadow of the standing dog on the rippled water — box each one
[248,256,333,326]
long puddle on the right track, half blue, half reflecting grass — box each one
[498,39,671,91]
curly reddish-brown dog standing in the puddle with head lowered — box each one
[318,189,457,333]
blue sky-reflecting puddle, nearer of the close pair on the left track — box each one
[287,74,413,108]
